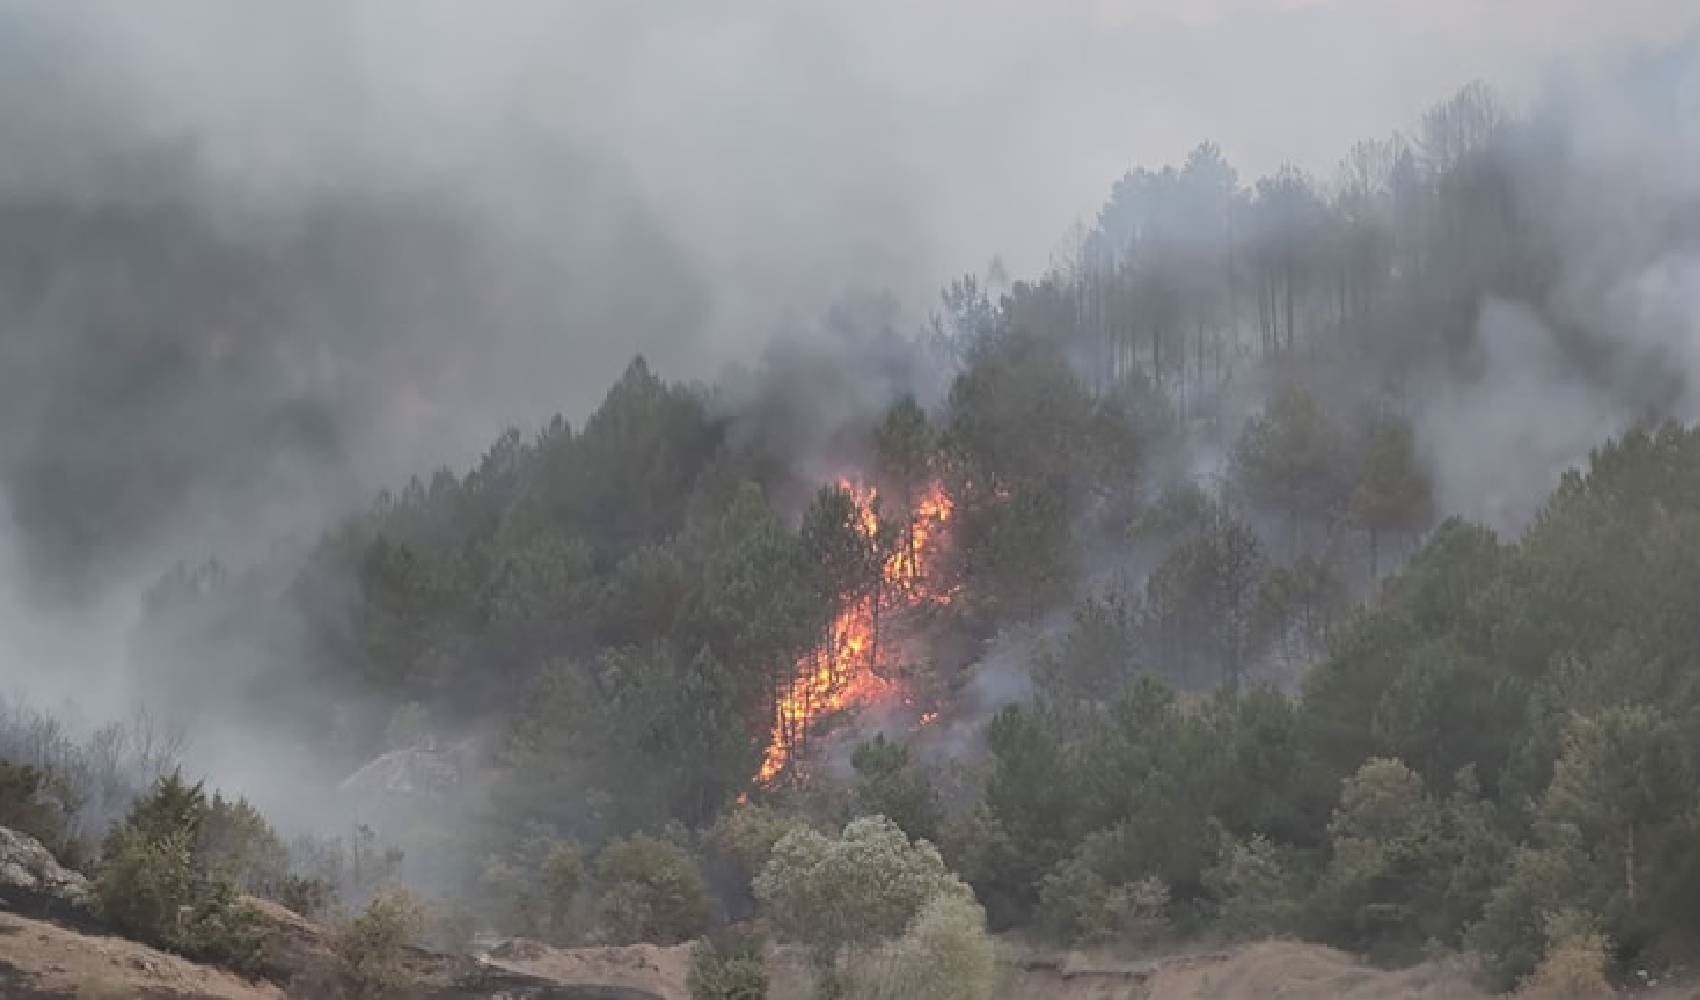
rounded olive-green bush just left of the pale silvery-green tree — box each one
[597,833,709,944]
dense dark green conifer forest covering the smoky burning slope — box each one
[14,62,1700,995]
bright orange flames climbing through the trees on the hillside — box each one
[757,480,955,786]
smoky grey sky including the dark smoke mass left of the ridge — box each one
[0,0,1700,602]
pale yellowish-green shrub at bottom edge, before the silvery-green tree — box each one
[848,893,998,1000]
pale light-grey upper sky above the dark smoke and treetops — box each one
[39,0,1700,352]
